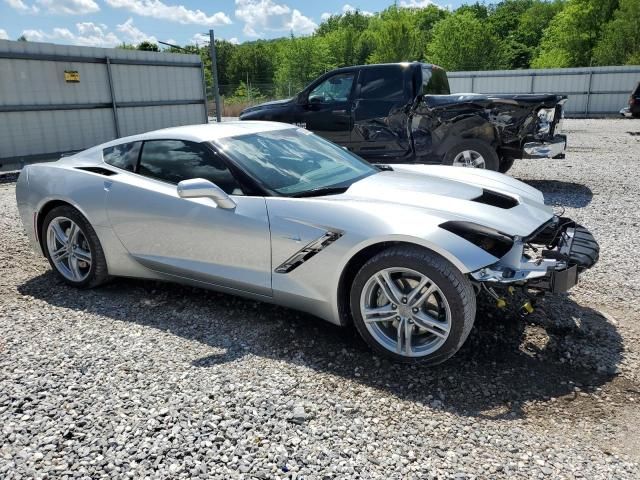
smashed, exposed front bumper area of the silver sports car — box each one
[471,217,600,293]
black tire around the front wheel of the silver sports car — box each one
[349,246,476,365]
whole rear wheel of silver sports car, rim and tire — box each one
[42,206,109,288]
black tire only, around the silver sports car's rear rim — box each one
[40,205,109,288]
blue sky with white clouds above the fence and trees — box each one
[0,0,450,47]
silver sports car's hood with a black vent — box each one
[333,165,553,237]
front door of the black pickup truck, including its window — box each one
[296,71,357,147]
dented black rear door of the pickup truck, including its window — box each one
[351,64,412,161]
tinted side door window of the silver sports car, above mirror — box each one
[138,140,242,195]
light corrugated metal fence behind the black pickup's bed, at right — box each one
[448,66,640,116]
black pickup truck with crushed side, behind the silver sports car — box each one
[240,62,567,172]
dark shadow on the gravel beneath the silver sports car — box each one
[18,272,622,419]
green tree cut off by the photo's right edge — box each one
[593,0,640,65]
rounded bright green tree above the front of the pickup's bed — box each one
[426,10,504,71]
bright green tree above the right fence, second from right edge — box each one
[532,0,618,68]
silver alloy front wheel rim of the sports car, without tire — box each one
[360,267,451,357]
